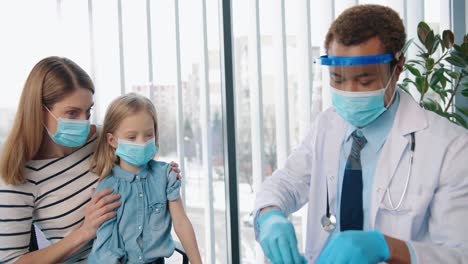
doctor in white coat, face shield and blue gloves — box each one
[255,5,468,264]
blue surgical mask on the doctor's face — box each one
[330,87,387,127]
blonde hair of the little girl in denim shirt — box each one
[91,93,159,180]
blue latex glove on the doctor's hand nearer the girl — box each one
[257,210,307,264]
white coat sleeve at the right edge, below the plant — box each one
[407,134,468,263]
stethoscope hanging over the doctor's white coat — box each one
[321,132,416,232]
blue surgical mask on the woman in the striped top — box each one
[44,106,90,148]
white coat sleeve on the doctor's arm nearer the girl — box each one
[254,119,317,219]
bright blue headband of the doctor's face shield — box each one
[314,53,395,66]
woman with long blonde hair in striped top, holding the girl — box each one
[0,57,177,263]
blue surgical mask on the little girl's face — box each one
[115,138,158,167]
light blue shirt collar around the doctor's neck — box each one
[345,90,400,153]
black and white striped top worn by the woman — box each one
[0,133,98,263]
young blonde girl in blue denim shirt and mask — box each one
[88,93,201,263]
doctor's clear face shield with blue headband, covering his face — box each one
[315,53,395,127]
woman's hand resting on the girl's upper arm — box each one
[80,188,121,241]
